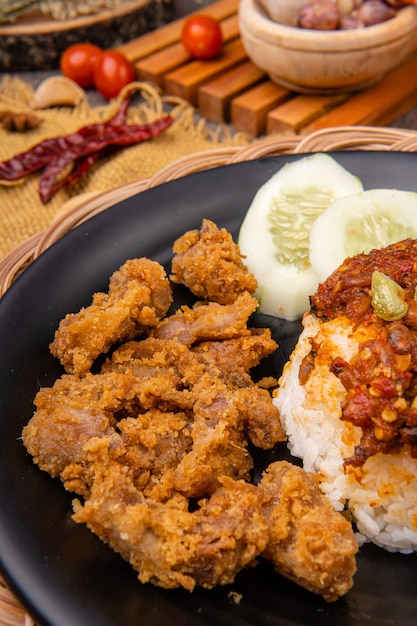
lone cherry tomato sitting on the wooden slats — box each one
[181,15,223,59]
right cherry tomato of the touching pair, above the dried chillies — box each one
[93,50,135,100]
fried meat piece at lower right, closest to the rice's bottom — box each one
[259,461,358,602]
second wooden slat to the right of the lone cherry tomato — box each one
[198,61,266,124]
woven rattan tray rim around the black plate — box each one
[0,126,417,626]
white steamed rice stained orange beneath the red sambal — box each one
[274,313,417,553]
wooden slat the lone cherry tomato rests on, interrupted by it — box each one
[135,15,239,87]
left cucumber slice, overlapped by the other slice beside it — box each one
[238,153,363,321]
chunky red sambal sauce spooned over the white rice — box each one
[303,239,417,467]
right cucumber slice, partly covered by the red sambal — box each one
[310,189,417,281]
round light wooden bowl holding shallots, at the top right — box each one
[239,0,417,94]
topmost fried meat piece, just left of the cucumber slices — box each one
[171,219,257,304]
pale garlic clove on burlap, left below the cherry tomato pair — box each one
[31,76,85,109]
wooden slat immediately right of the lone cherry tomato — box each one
[163,39,246,106]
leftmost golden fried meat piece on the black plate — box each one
[22,373,133,495]
